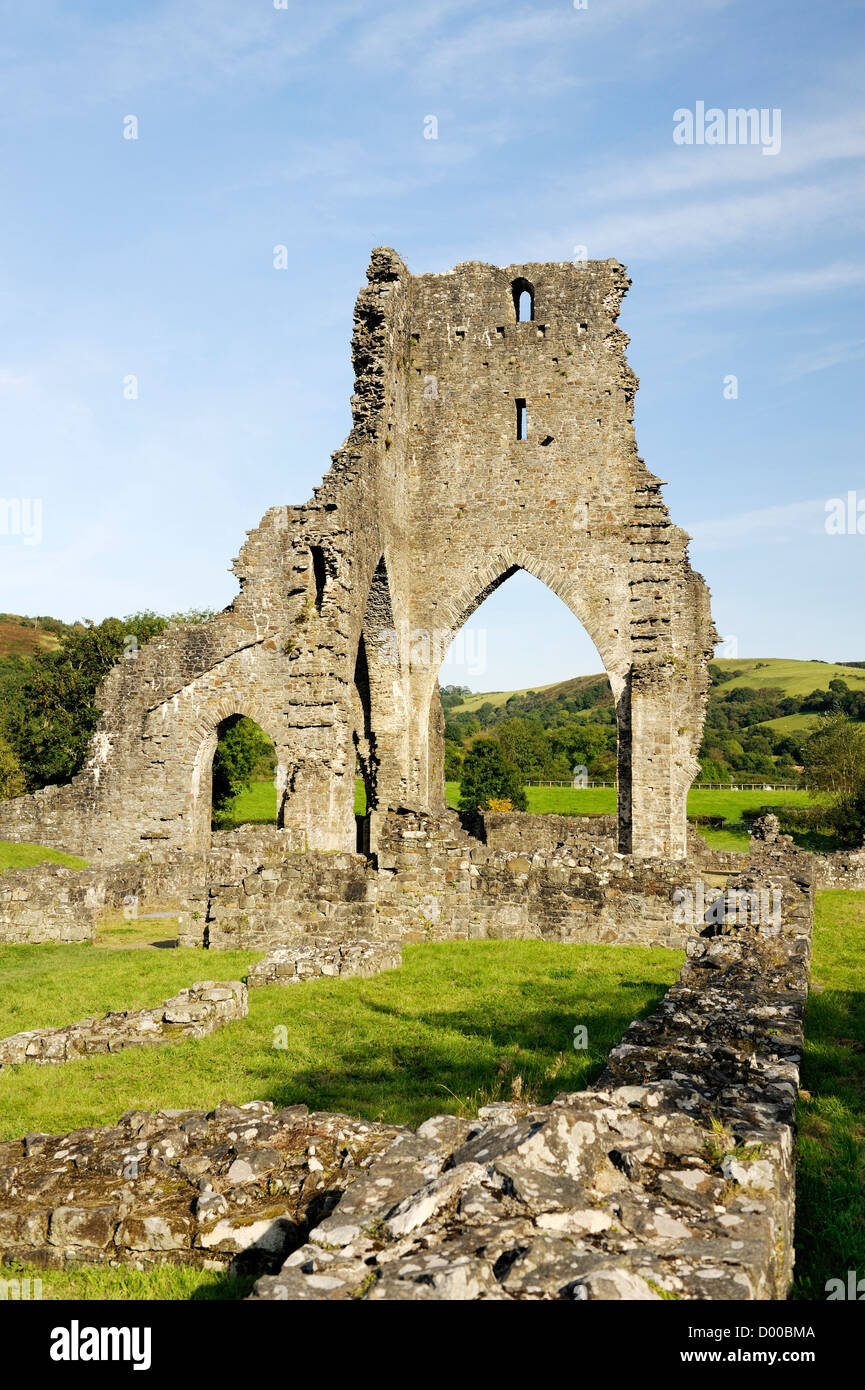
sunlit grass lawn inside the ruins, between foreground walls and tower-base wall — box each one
[0,941,683,1138]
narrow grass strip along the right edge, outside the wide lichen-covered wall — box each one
[794,891,865,1300]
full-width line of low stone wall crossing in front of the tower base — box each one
[0,812,865,951]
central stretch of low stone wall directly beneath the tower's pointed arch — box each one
[179,813,806,951]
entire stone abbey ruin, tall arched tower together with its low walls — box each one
[0,249,865,1301]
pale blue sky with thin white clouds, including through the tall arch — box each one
[0,0,865,689]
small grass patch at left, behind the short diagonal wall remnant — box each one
[0,939,261,1039]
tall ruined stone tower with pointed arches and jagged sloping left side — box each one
[0,249,716,859]
